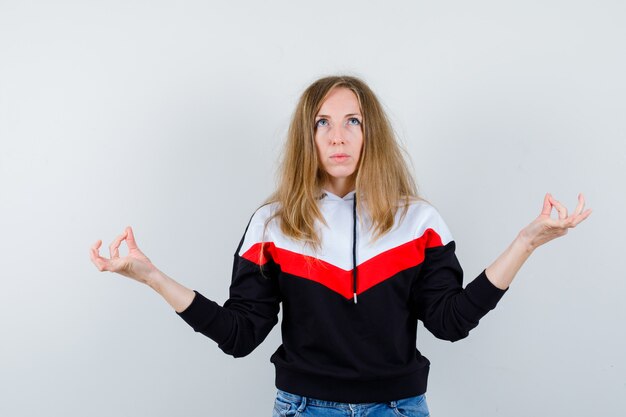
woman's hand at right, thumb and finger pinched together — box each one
[520,193,591,249]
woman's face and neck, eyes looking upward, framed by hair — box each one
[315,87,363,194]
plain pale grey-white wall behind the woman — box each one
[0,0,626,417]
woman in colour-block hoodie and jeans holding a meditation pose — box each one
[91,76,591,417]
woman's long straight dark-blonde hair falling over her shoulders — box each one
[266,76,419,248]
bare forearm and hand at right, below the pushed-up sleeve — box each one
[486,194,591,289]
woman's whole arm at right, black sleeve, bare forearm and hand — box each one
[413,194,591,341]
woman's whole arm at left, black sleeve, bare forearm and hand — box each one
[91,223,280,357]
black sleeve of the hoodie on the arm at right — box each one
[412,241,506,342]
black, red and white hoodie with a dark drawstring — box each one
[179,191,506,403]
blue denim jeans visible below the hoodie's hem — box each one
[272,390,430,417]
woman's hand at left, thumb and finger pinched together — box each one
[91,226,158,284]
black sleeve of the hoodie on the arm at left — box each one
[178,216,281,358]
